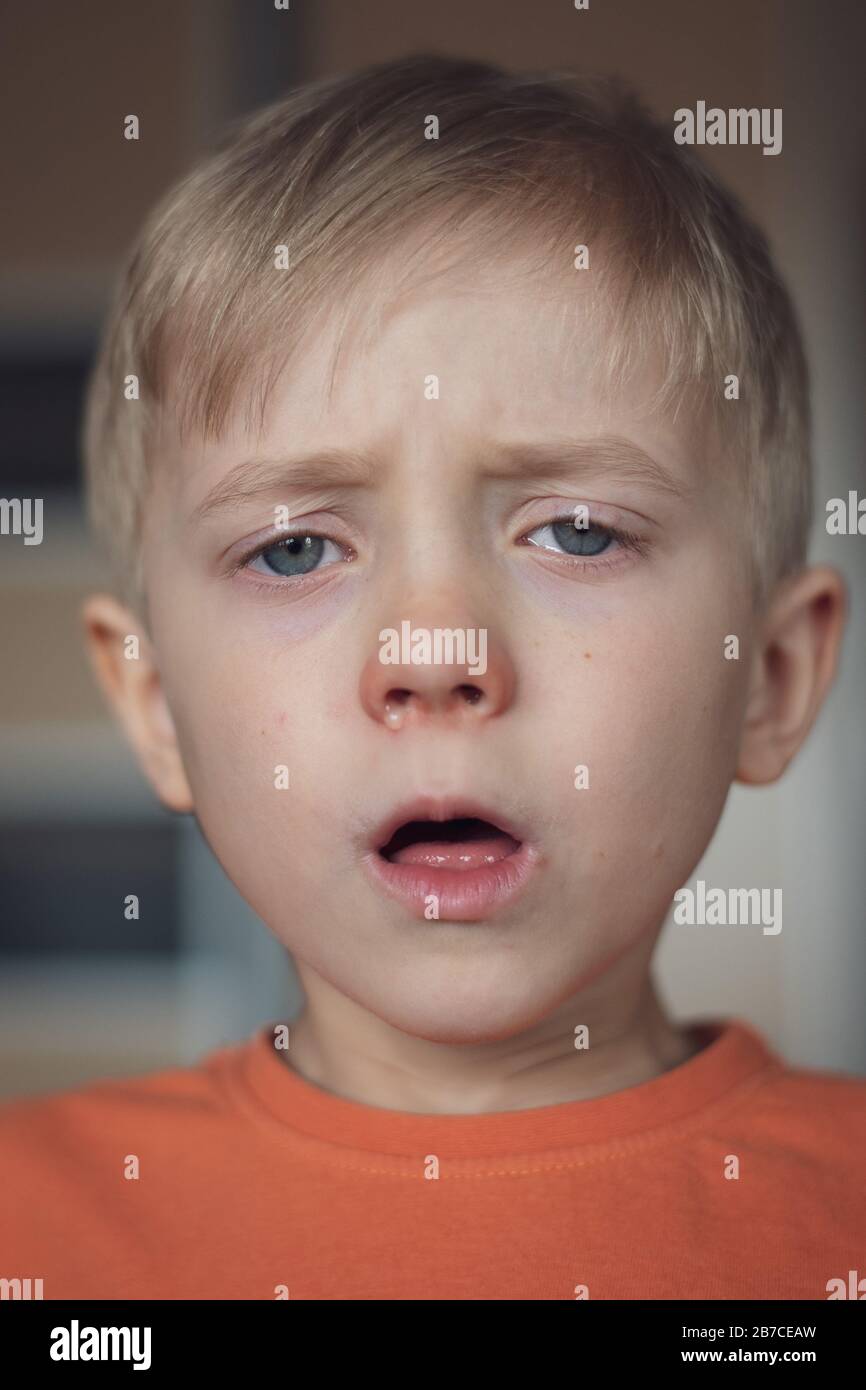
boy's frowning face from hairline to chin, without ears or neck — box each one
[136,244,753,1041]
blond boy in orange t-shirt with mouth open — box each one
[0,57,866,1300]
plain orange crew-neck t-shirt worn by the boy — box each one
[0,1019,866,1300]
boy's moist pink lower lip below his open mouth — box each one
[364,844,539,922]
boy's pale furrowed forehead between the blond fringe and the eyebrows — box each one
[159,229,706,491]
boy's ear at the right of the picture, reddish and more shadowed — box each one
[737,566,848,784]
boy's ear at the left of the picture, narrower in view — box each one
[81,594,193,813]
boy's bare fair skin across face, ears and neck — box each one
[83,244,845,1113]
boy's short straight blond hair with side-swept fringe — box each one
[82,54,812,602]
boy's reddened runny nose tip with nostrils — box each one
[360,617,514,733]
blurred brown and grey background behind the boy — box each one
[0,0,866,1097]
